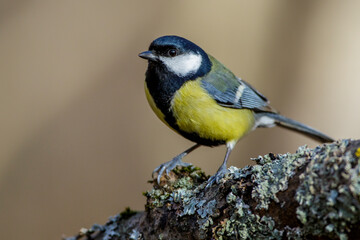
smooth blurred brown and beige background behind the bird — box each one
[0,0,360,239]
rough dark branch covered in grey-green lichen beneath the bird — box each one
[64,140,360,240]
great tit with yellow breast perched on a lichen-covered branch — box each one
[139,36,333,186]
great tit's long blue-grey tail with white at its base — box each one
[256,112,334,143]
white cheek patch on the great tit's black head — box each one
[159,53,202,77]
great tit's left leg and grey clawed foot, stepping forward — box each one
[152,144,200,184]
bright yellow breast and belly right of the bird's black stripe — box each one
[170,80,255,143]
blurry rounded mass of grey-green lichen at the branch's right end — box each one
[296,140,360,240]
